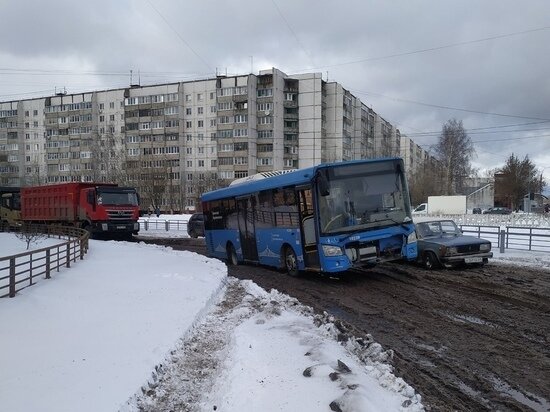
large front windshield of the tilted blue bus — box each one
[318,162,411,235]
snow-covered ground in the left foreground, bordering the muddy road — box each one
[0,233,423,412]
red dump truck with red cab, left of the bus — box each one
[21,183,139,237]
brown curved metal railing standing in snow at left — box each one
[0,225,90,298]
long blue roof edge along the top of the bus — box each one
[201,157,400,202]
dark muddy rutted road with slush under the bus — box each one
[139,239,550,411]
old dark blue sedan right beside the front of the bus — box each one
[416,220,493,269]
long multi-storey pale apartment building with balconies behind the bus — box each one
[0,68,410,210]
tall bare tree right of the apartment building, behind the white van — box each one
[434,119,475,195]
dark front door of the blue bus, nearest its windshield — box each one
[297,186,321,270]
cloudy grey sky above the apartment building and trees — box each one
[0,0,550,182]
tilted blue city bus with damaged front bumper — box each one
[201,158,417,276]
